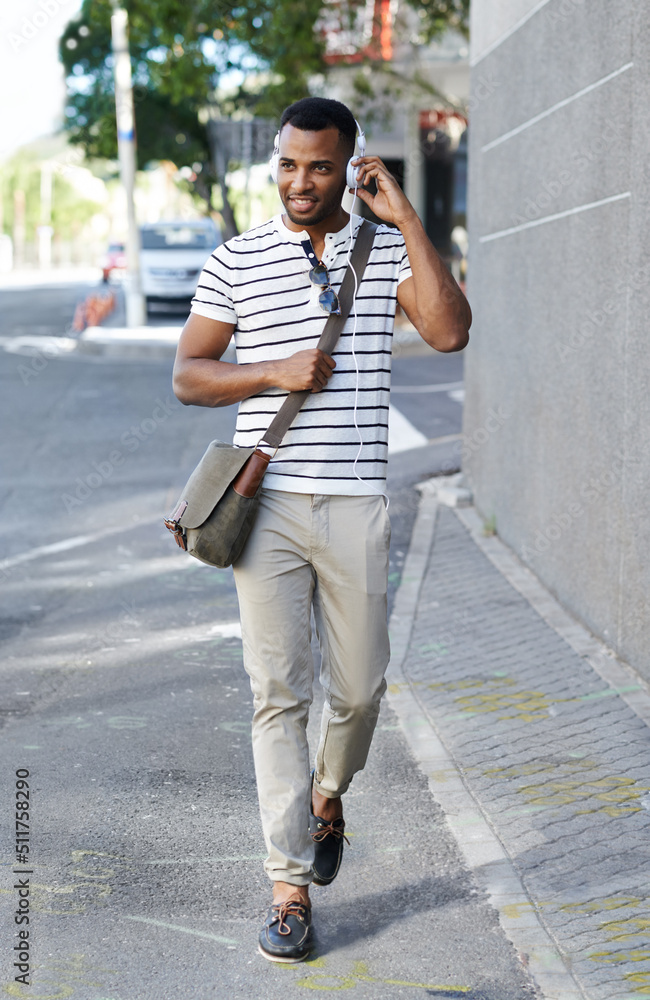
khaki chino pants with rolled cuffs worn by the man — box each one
[234,489,390,885]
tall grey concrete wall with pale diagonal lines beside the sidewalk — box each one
[464,0,650,677]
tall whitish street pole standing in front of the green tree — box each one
[111,0,147,327]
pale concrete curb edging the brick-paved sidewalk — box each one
[386,489,585,1000]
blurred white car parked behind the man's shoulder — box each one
[140,219,222,307]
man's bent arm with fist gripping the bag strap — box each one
[173,313,336,406]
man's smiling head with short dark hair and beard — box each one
[278,97,357,228]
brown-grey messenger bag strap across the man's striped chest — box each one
[260,219,377,448]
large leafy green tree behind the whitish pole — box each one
[60,0,469,235]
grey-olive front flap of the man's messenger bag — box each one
[169,441,255,528]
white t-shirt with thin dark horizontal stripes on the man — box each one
[192,215,411,496]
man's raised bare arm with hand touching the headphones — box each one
[355,156,472,351]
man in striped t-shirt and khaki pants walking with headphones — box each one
[174,98,471,962]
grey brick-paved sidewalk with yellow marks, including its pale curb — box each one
[389,480,650,1000]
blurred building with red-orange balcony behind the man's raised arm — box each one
[321,0,469,260]
